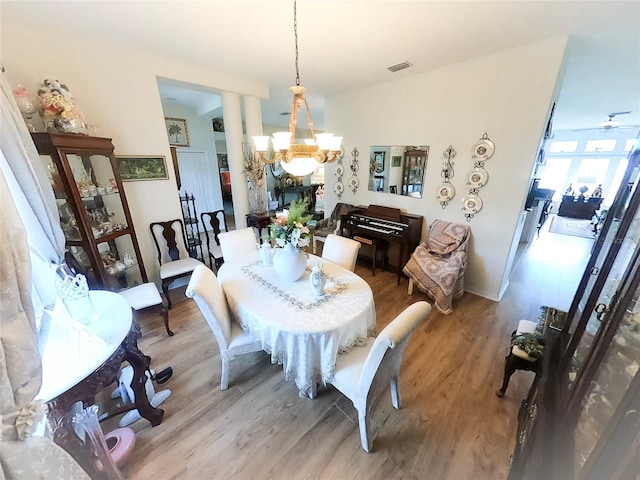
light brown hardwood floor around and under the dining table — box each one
[116,222,593,479]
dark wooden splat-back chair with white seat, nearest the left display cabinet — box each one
[149,218,202,309]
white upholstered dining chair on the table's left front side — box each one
[186,265,262,390]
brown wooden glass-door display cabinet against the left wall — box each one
[31,133,147,291]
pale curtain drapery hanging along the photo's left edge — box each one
[0,69,89,480]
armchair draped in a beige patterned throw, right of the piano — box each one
[403,220,470,315]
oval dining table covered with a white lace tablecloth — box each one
[218,251,376,398]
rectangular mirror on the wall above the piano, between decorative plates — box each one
[369,145,429,198]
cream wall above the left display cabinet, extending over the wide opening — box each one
[0,20,268,282]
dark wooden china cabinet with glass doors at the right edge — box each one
[509,142,640,480]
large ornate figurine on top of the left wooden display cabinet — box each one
[38,78,87,135]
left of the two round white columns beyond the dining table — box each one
[222,92,249,228]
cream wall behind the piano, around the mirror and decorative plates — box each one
[325,37,567,300]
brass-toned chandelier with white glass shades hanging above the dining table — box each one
[253,0,342,177]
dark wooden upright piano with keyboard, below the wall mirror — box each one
[340,205,422,284]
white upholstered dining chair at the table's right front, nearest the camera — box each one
[330,302,431,453]
